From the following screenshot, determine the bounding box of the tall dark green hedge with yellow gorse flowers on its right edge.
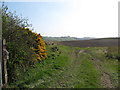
[2,3,47,83]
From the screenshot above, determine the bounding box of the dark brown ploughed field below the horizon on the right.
[61,38,120,47]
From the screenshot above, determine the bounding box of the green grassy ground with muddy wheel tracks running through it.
[7,45,118,88]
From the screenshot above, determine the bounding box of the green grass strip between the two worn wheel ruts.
[75,53,101,88]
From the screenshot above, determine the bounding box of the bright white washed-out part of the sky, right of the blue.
[51,0,118,37]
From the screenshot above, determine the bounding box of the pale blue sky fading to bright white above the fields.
[4,0,119,38]
